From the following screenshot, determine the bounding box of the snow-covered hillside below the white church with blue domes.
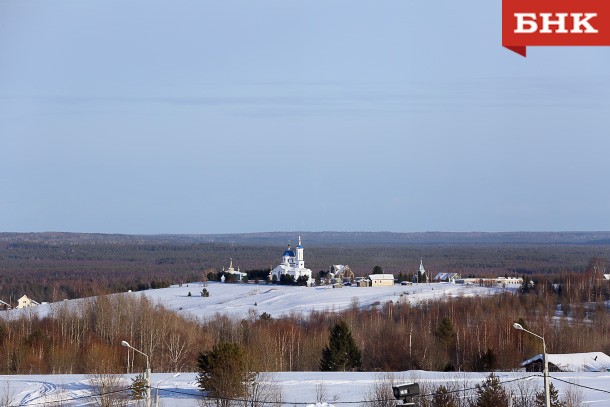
[10,282,504,318]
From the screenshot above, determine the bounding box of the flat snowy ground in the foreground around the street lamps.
[0,371,610,407]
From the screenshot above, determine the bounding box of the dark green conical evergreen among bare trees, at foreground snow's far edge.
[320,321,362,372]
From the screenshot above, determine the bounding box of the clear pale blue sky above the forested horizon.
[0,0,610,234]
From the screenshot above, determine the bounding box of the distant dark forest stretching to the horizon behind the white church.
[0,232,610,304]
